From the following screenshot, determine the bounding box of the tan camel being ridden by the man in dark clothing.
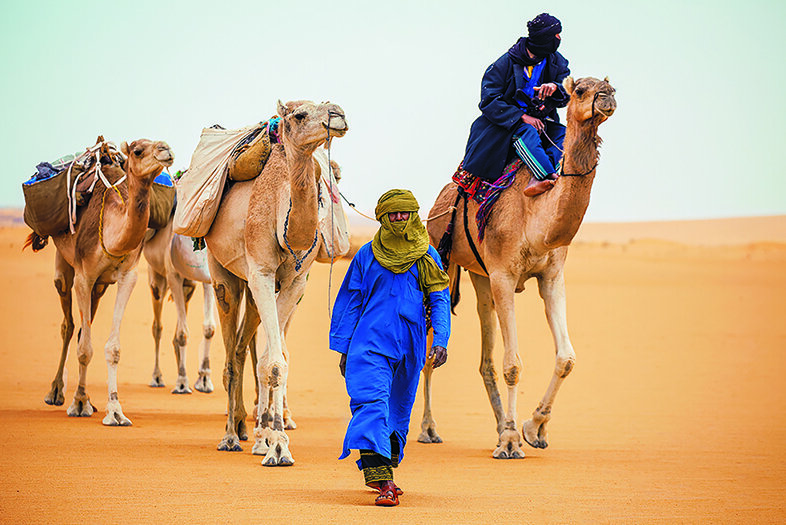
[418,77,617,459]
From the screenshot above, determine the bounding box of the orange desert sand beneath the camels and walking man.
[0,217,786,524]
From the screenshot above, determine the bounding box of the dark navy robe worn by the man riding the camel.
[464,53,570,181]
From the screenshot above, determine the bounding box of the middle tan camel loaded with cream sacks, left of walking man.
[205,101,348,466]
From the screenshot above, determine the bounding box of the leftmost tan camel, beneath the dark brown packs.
[34,139,174,426]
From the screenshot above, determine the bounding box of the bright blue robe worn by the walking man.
[330,242,450,460]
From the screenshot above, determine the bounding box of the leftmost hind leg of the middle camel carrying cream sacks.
[208,254,243,452]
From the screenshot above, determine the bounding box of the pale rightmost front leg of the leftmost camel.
[103,270,137,427]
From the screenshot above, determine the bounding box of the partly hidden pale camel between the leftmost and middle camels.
[143,216,216,394]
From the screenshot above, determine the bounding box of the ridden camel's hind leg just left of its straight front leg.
[469,273,505,434]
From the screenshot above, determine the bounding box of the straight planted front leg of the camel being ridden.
[489,272,524,459]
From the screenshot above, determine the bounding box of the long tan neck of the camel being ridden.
[528,119,599,250]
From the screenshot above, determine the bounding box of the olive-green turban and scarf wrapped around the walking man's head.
[371,190,450,297]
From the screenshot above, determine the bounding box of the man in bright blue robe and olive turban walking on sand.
[330,190,450,506]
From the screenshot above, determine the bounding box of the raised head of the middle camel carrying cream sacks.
[278,100,349,153]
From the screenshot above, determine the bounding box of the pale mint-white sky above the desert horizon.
[0,0,786,222]
